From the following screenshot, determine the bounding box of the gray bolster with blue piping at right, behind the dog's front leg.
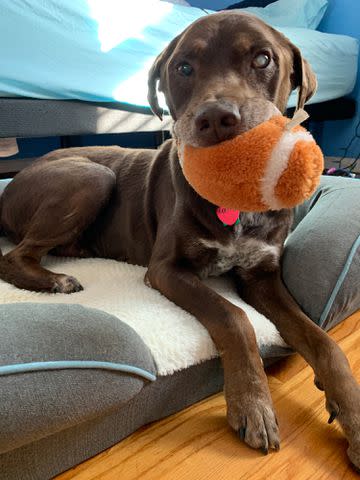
[282,176,360,329]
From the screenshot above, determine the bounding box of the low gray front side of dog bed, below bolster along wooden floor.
[0,359,223,480]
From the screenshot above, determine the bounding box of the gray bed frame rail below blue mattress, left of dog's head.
[0,98,171,138]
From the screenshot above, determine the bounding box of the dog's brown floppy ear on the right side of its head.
[291,45,317,108]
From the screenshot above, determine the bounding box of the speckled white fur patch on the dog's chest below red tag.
[200,237,280,278]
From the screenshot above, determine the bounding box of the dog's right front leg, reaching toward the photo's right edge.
[238,271,360,468]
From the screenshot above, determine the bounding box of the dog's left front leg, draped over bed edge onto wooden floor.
[145,261,279,453]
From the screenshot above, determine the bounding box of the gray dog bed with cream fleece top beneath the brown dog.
[0,178,360,480]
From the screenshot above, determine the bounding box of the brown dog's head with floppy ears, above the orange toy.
[148,12,316,146]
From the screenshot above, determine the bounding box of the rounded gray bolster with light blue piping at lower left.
[0,303,156,453]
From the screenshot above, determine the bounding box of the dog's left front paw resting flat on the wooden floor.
[227,392,280,454]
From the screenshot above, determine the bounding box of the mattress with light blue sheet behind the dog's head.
[0,0,358,106]
